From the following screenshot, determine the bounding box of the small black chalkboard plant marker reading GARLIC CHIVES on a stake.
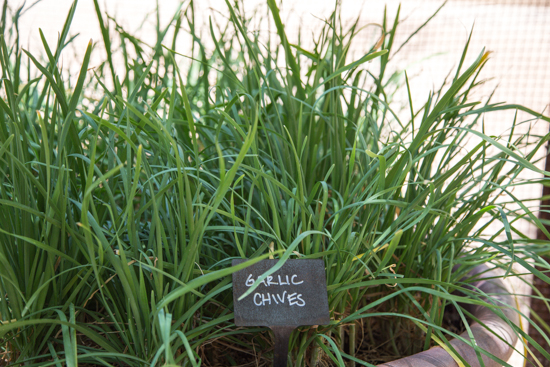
[233,259,330,367]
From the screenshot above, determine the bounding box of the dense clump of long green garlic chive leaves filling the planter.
[0,0,550,367]
